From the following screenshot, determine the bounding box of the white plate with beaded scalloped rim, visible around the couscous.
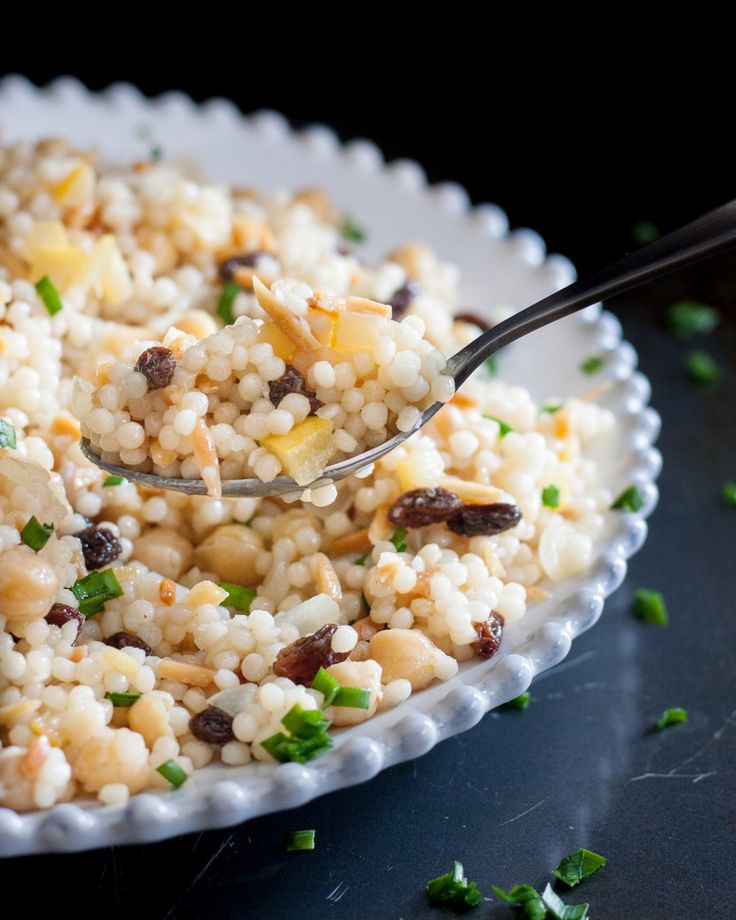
[0,77,661,856]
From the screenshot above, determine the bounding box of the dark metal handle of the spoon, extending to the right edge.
[446,201,736,388]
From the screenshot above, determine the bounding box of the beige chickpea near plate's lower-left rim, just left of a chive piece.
[73,728,151,793]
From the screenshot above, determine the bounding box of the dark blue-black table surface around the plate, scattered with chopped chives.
[0,91,736,920]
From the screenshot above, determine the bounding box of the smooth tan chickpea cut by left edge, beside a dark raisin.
[0,547,59,626]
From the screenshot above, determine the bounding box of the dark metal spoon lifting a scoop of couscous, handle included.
[81,201,736,496]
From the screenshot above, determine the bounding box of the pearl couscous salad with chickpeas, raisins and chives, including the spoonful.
[0,139,614,811]
